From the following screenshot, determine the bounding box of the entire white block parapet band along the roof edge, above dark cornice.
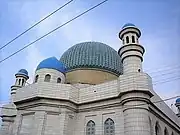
[12,73,179,128]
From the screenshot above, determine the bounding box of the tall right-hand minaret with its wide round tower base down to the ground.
[118,23,153,135]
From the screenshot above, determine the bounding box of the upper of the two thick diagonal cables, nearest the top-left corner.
[0,0,73,50]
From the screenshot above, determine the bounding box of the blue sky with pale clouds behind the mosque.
[0,0,180,114]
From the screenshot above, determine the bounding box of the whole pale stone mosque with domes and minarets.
[1,23,180,135]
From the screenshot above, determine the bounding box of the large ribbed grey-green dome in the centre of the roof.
[60,42,122,75]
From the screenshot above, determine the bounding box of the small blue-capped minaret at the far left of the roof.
[11,69,29,101]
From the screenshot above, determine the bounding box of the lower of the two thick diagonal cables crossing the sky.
[0,0,108,63]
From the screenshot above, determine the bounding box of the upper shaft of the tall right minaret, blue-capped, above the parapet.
[118,23,145,73]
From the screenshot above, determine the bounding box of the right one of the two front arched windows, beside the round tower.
[104,118,115,135]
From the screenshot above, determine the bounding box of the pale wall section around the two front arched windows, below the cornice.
[74,108,124,135]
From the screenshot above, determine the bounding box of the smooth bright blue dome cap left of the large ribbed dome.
[36,57,66,73]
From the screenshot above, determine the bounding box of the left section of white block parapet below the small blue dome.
[14,82,78,102]
